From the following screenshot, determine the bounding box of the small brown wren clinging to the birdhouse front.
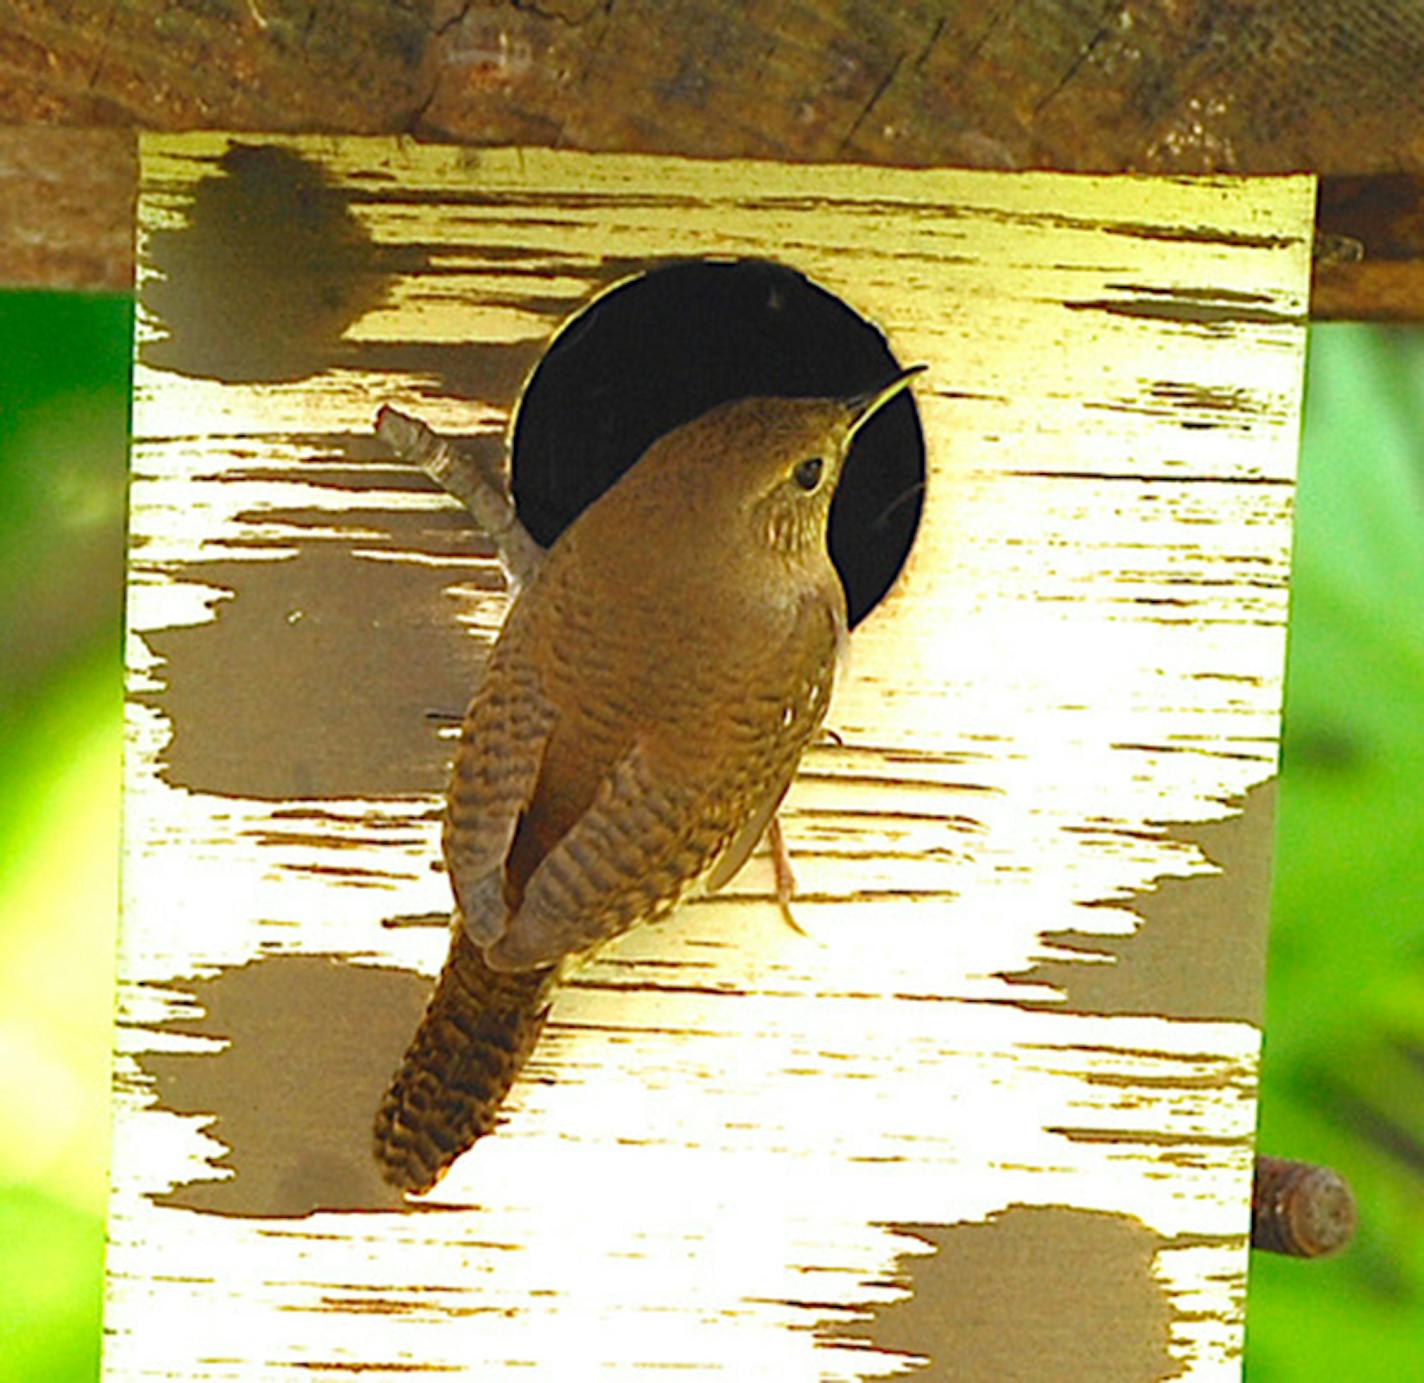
[375,366,923,1192]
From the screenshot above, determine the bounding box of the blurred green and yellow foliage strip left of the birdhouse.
[0,292,132,1383]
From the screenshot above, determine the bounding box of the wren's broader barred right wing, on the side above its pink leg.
[486,742,763,970]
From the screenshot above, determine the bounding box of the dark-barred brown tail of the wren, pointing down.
[375,916,555,1194]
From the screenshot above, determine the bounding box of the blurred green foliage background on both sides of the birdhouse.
[0,293,1424,1383]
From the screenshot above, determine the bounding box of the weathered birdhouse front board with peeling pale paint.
[105,134,1313,1380]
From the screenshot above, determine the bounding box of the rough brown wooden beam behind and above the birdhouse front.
[0,0,1424,311]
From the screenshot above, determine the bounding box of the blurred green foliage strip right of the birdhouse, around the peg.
[1246,325,1424,1383]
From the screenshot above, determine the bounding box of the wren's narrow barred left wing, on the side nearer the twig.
[444,665,557,944]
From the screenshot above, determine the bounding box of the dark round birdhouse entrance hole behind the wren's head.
[513,259,924,624]
